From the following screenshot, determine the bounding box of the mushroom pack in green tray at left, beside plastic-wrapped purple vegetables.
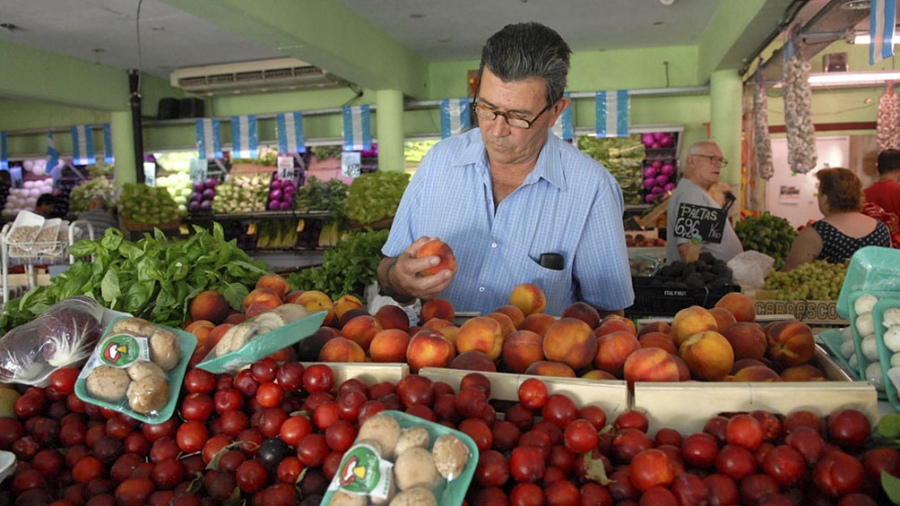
[75,317,197,423]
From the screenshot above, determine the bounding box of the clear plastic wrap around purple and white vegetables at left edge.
[0,296,104,384]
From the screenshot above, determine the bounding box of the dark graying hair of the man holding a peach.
[478,22,572,104]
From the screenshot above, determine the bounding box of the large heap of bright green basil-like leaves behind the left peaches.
[0,223,269,331]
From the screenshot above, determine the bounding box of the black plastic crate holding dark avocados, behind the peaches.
[625,277,741,318]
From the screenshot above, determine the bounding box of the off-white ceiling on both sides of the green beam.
[0,0,760,78]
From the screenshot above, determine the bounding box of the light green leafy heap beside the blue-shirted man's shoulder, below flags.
[346,170,409,225]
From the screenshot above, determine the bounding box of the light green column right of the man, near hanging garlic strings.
[709,69,743,185]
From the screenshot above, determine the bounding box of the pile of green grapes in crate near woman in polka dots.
[765,260,847,300]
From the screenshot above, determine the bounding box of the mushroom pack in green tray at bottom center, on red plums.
[322,411,478,506]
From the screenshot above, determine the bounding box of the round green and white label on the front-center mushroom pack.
[329,444,393,499]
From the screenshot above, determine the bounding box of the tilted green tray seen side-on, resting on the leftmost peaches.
[197,311,328,374]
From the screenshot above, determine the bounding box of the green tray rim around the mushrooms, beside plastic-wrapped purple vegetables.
[75,316,197,424]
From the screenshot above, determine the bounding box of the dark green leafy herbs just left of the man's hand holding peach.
[287,228,390,300]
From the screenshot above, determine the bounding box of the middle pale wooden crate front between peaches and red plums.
[419,367,628,420]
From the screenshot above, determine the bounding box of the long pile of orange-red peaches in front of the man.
[185,274,824,381]
